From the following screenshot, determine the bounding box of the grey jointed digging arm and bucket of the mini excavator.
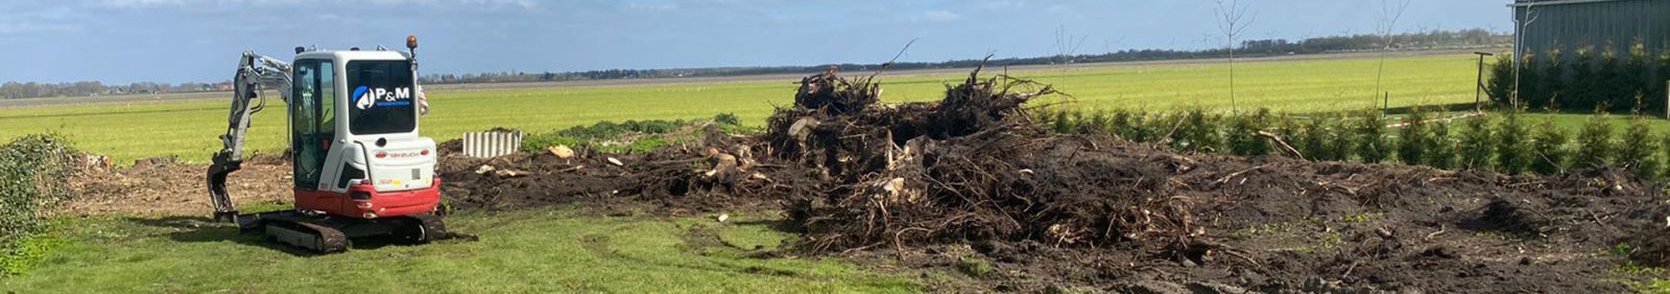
[209,52,291,226]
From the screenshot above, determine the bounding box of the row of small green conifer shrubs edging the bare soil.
[1037,107,1670,179]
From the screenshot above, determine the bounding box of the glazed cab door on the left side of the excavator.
[291,60,336,190]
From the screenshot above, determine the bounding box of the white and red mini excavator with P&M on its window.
[209,35,448,252]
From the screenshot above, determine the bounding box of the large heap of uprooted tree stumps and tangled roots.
[765,67,1192,252]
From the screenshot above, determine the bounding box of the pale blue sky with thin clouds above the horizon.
[0,0,1513,84]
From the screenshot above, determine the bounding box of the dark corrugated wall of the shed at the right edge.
[1513,0,1670,57]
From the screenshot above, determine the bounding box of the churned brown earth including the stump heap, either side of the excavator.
[61,68,1670,292]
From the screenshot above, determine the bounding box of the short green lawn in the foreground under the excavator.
[0,209,928,292]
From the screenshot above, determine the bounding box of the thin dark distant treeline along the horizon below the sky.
[0,28,1513,99]
